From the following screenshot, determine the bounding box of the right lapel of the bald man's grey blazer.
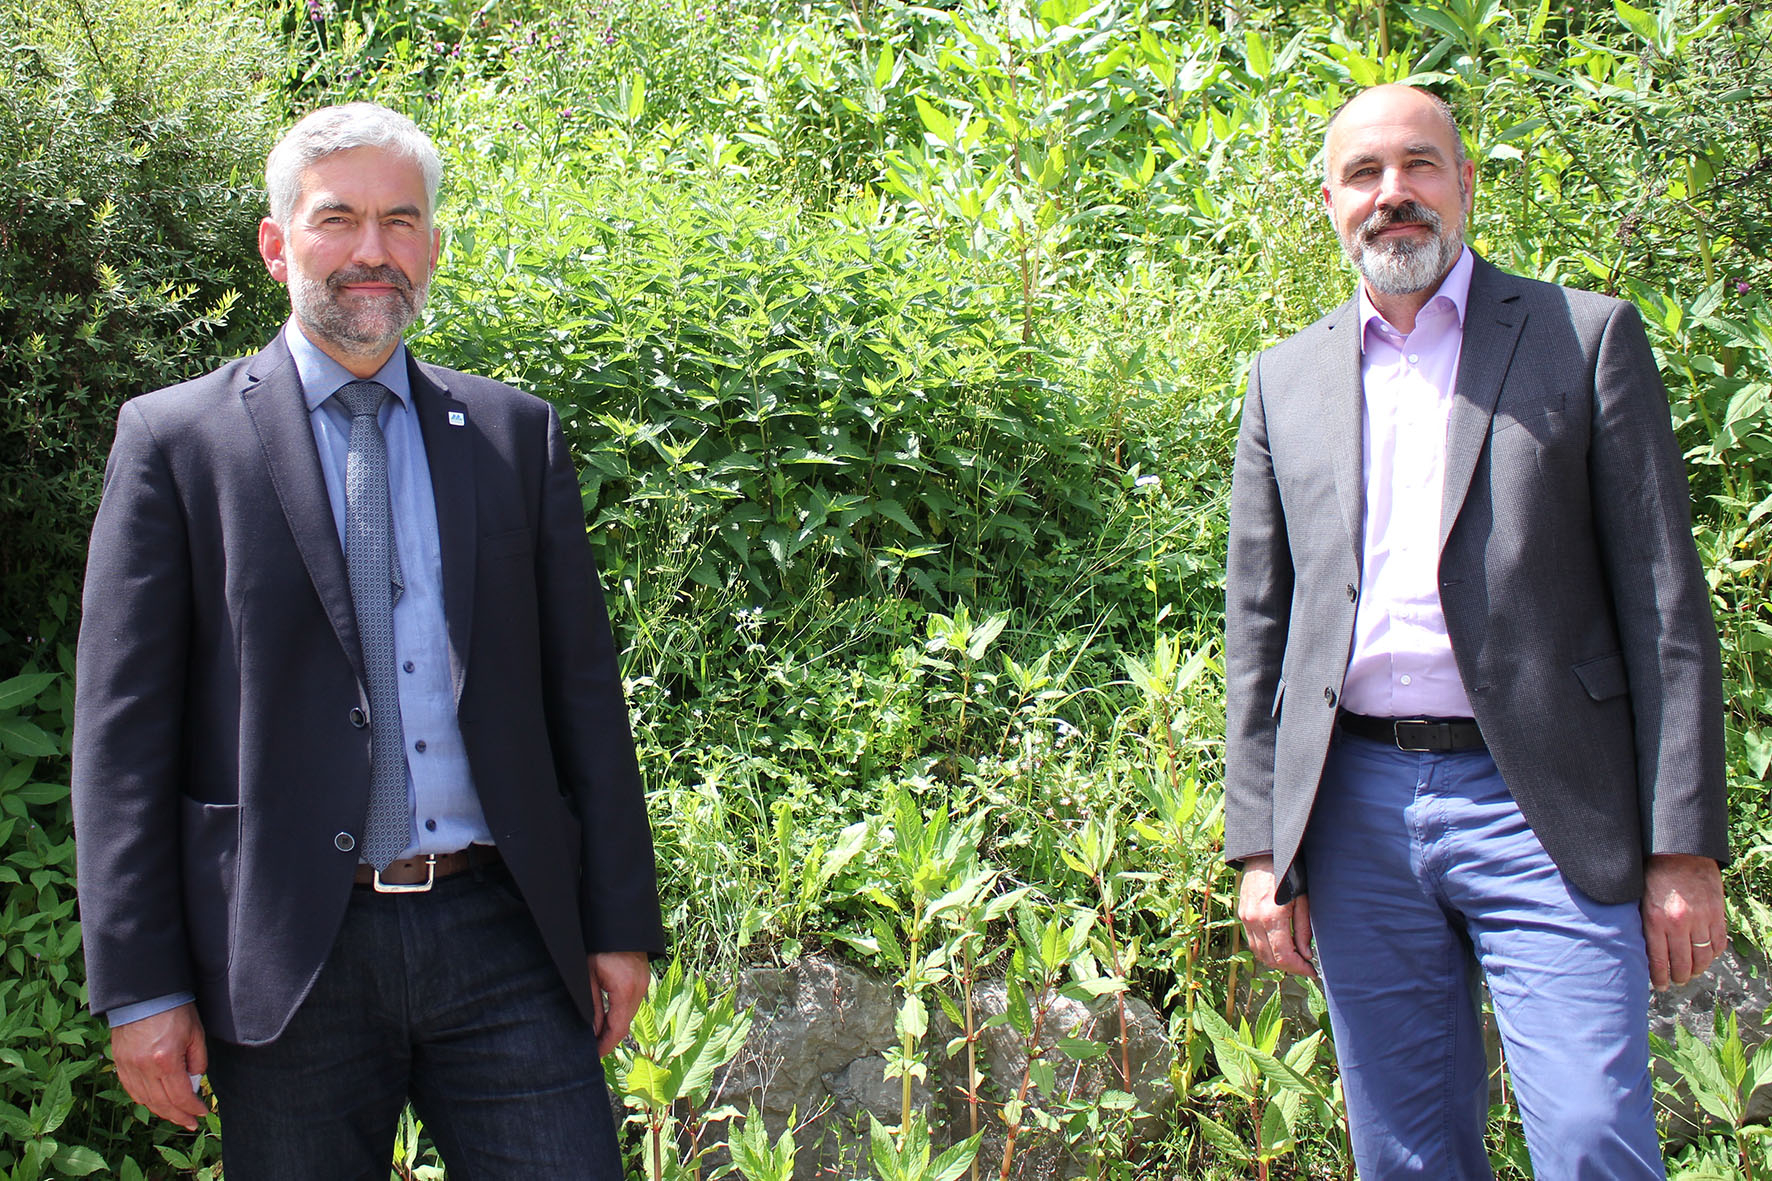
[1439,259,1526,550]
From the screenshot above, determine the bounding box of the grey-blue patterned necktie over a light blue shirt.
[333,381,411,871]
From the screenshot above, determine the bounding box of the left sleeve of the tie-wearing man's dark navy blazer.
[73,403,193,1013]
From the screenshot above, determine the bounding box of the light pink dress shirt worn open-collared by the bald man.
[1341,248,1473,718]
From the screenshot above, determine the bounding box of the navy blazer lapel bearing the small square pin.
[406,358,480,706]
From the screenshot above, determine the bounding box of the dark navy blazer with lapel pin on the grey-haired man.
[73,337,663,1044]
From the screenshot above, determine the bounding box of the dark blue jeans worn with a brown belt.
[209,865,622,1181]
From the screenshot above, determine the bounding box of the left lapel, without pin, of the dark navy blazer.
[241,335,367,684]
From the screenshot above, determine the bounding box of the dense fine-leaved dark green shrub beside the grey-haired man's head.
[0,0,287,669]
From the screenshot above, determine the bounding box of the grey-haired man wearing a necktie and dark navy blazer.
[73,103,663,1181]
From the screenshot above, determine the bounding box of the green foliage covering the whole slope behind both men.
[0,0,1772,1181]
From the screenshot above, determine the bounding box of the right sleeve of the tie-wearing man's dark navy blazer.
[537,406,665,956]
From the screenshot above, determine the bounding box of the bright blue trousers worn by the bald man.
[1304,732,1666,1181]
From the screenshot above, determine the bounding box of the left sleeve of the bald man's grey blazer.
[1224,356,1294,862]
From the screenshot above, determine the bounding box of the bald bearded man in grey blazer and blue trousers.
[1224,87,1728,1181]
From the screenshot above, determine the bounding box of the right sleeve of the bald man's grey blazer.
[1588,303,1728,864]
